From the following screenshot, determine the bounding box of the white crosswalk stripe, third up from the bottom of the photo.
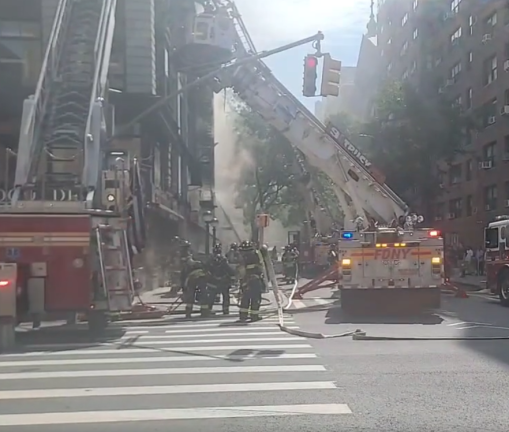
[0,365,326,381]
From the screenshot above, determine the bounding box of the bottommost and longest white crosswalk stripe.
[0,404,352,426]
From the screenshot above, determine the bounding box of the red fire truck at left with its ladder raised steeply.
[0,0,145,331]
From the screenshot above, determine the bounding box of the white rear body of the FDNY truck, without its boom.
[338,228,444,310]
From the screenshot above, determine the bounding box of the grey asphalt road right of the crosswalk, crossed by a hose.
[288,284,509,432]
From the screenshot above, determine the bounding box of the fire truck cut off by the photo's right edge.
[484,216,509,307]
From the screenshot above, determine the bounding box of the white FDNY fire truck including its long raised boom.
[191,0,444,308]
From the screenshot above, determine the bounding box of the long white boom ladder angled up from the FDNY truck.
[212,2,411,230]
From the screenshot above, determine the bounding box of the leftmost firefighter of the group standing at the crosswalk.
[181,242,211,318]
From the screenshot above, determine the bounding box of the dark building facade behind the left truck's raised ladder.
[0,0,214,286]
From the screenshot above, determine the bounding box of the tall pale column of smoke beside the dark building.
[214,94,249,243]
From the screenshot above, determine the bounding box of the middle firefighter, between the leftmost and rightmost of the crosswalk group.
[208,244,235,315]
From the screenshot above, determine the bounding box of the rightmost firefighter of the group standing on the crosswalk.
[238,241,265,322]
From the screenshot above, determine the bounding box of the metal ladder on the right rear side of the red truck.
[95,224,135,312]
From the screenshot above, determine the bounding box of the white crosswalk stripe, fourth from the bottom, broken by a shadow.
[0,339,313,361]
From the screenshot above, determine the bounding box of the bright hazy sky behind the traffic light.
[235,0,370,111]
